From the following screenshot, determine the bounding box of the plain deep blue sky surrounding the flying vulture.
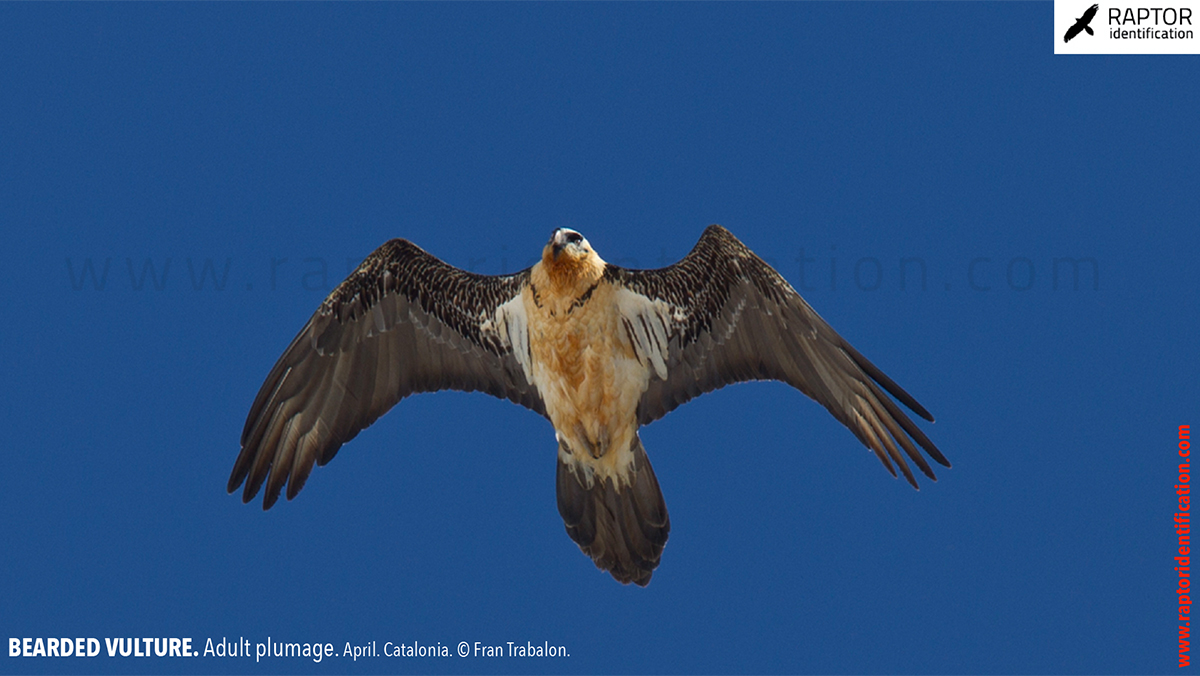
[0,2,1200,674]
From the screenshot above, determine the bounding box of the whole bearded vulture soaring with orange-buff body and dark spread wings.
[228,226,950,586]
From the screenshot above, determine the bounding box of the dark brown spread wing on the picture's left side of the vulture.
[228,239,545,509]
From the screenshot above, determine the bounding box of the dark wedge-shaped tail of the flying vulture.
[557,436,671,587]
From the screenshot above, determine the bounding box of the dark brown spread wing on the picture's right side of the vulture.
[606,226,950,487]
